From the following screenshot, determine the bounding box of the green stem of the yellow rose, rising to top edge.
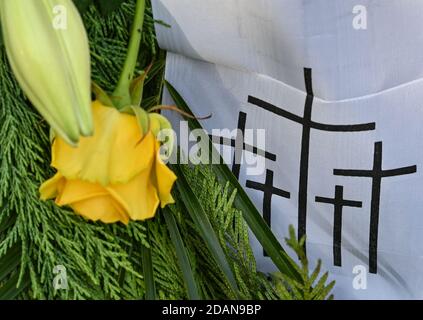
[112,0,145,109]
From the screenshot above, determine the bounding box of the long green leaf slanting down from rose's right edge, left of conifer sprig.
[170,165,238,295]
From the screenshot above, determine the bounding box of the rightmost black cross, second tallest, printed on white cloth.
[333,142,417,273]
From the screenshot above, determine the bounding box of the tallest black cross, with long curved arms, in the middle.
[248,68,376,249]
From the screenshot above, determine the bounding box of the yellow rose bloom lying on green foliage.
[40,101,176,224]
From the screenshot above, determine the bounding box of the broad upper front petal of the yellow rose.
[52,101,154,186]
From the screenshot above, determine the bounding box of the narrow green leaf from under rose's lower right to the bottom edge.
[163,207,201,300]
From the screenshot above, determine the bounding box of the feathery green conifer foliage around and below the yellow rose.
[0,0,331,299]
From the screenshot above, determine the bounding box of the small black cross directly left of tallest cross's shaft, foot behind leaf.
[246,170,291,256]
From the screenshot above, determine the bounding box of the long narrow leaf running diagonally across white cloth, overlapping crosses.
[165,81,301,281]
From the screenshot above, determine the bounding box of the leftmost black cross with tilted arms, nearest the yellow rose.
[210,112,276,179]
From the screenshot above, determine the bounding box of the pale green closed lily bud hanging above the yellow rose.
[0,0,93,144]
